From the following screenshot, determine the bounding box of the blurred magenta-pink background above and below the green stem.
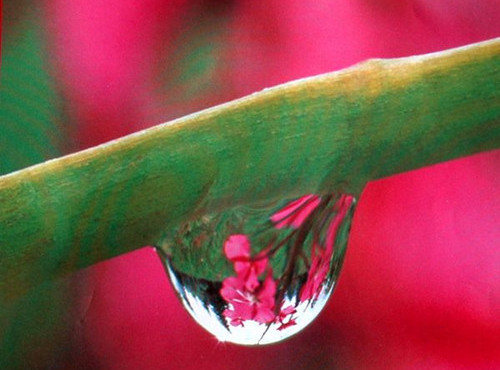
[46,0,500,369]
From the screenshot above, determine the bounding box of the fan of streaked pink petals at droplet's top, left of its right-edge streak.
[271,194,321,229]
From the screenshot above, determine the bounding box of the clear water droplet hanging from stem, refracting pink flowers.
[158,194,354,345]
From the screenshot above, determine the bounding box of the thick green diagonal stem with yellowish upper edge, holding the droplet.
[0,39,500,304]
